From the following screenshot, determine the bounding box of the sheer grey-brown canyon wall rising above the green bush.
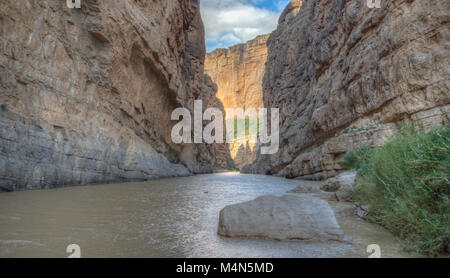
[245,0,450,179]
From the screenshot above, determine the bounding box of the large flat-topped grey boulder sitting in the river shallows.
[218,195,344,241]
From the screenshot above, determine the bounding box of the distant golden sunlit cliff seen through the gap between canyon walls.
[205,35,269,168]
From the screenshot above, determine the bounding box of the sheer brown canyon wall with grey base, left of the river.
[0,0,225,190]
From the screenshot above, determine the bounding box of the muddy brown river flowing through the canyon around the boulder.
[0,173,411,258]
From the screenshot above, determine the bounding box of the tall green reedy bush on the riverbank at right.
[344,123,450,256]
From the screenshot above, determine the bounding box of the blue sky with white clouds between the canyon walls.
[200,0,290,52]
